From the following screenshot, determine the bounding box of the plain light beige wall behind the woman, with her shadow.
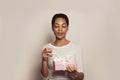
[0,0,120,80]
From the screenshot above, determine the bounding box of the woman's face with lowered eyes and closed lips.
[52,18,68,39]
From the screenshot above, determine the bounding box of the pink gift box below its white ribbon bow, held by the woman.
[54,62,74,71]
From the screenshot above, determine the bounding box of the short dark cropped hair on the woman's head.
[51,13,69,26]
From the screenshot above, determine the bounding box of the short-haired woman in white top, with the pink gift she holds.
[41,13,84,80]
